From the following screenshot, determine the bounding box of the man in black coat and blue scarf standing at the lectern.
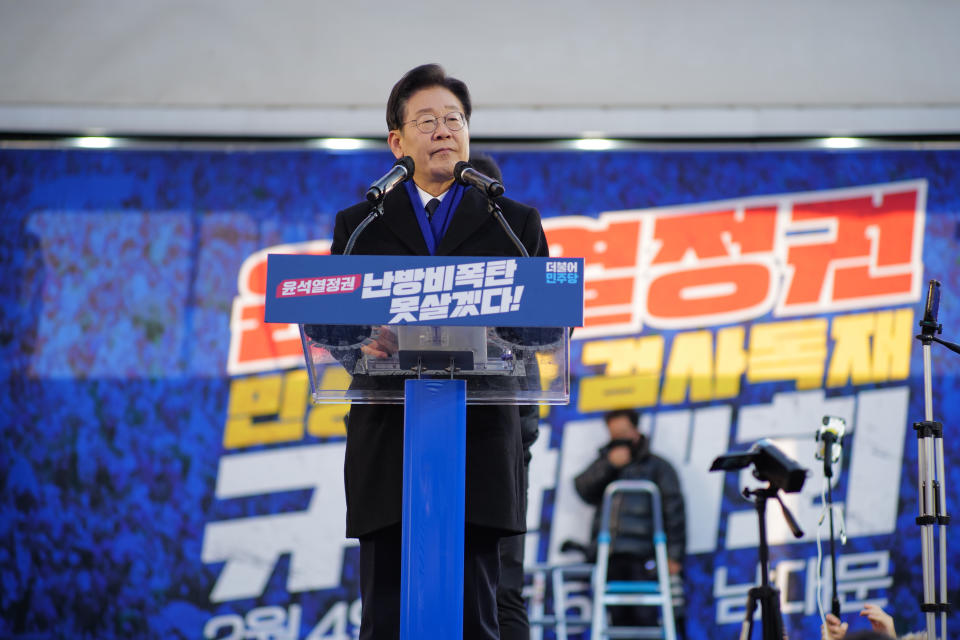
[330,65,548,640]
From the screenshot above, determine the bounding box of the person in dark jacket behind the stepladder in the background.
[574,409,687,631]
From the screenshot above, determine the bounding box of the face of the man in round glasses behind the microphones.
[387,86,470,195]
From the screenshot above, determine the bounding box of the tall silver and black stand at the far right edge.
[913,280,960,639]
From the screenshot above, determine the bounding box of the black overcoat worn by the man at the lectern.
[330,188,548,537]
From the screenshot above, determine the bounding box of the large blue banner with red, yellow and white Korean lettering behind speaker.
[0,149,960,640]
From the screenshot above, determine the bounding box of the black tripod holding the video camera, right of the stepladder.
[740,486,803,640]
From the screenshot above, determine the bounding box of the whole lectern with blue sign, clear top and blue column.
[265,255,583,640]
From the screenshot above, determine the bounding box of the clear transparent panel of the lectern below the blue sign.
[300,325,570,404]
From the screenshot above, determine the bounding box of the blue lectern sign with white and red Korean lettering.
[265,254,583,327]
